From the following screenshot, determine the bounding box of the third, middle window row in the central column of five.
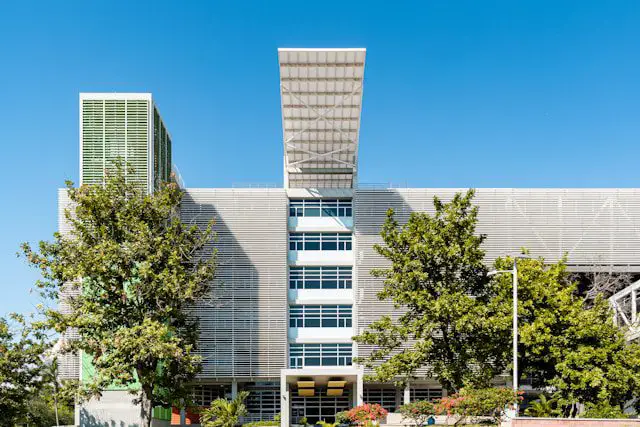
[289,266,353,289]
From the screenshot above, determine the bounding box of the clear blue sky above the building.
[0,0,640,315]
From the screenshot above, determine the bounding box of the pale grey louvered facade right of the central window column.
[354,188,640,375]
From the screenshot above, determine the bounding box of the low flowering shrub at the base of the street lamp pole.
[436,387,522,426]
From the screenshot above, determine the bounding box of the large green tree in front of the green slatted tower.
[23,162,215,426]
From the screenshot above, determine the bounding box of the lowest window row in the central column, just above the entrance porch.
[289,344,352,368]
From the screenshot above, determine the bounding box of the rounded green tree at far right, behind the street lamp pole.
[491,258,640,416]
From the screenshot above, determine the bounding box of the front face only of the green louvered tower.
[81,99,149,188]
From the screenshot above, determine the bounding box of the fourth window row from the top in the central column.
[289,305,351,328]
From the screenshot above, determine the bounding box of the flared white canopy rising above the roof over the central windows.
[278,48,366,188]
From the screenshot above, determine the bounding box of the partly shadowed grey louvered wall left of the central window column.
[181,189,287,379]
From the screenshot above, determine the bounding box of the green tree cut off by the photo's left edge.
[0,314,50,426]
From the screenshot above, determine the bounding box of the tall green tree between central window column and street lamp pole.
[354,190,508,393]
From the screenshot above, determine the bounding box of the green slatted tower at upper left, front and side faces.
[80,97,171,193]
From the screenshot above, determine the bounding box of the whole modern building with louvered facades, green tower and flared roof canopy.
[59,49,640,426]
